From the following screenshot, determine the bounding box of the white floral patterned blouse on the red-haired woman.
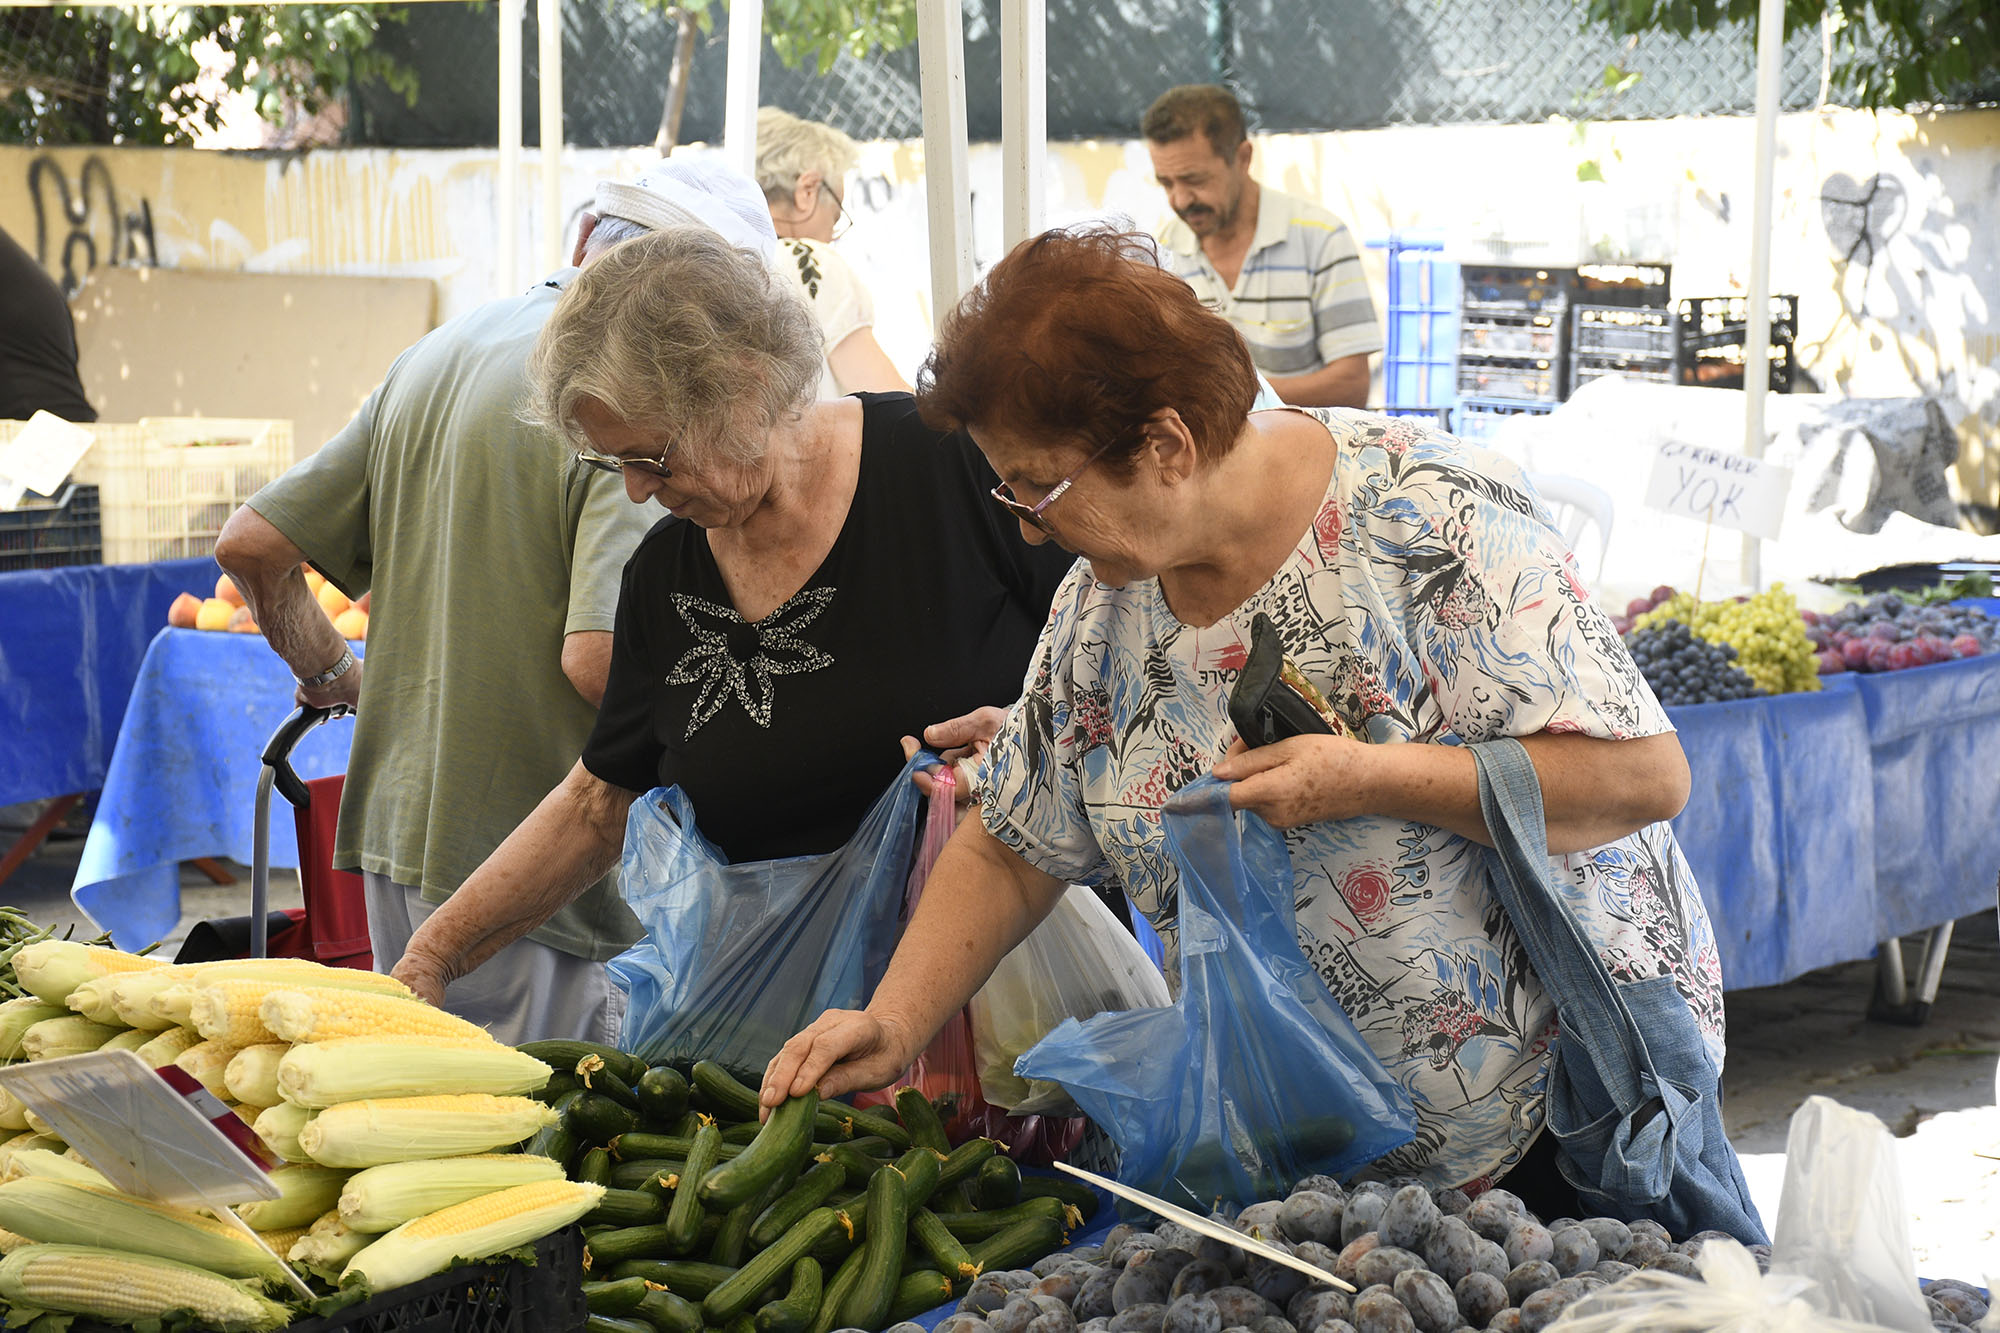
[982,410,1722,1185]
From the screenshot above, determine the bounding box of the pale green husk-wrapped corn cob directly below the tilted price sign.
[0,1177,282,1281]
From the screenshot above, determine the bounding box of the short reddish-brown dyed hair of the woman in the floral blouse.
[916,226,1256,468]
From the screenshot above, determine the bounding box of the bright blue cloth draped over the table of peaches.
[70,628,362,949]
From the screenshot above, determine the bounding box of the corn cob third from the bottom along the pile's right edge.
[298,1093,556,1167]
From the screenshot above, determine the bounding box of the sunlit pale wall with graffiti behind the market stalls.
[0,110,2000,504]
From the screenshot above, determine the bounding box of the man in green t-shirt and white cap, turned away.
[216,158,776,1045]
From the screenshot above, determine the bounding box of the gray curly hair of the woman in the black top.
[522,226,822,462]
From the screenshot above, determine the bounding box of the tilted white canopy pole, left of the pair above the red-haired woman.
[916,0,972,326]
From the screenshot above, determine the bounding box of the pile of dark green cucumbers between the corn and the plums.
[520,1041,1098,1333]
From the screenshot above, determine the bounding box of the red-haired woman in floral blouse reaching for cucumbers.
[764,230,1722,1215]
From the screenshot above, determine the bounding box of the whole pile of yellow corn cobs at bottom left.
[0,941,604,1331]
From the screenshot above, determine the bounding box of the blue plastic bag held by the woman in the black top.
[608,755,938,1087]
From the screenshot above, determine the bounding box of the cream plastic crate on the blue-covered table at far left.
[0,416,292,564]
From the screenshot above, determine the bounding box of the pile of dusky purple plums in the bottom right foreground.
[916,1175,1986,1333]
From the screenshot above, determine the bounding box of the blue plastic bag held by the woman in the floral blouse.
[1014,779,1416,1211]
